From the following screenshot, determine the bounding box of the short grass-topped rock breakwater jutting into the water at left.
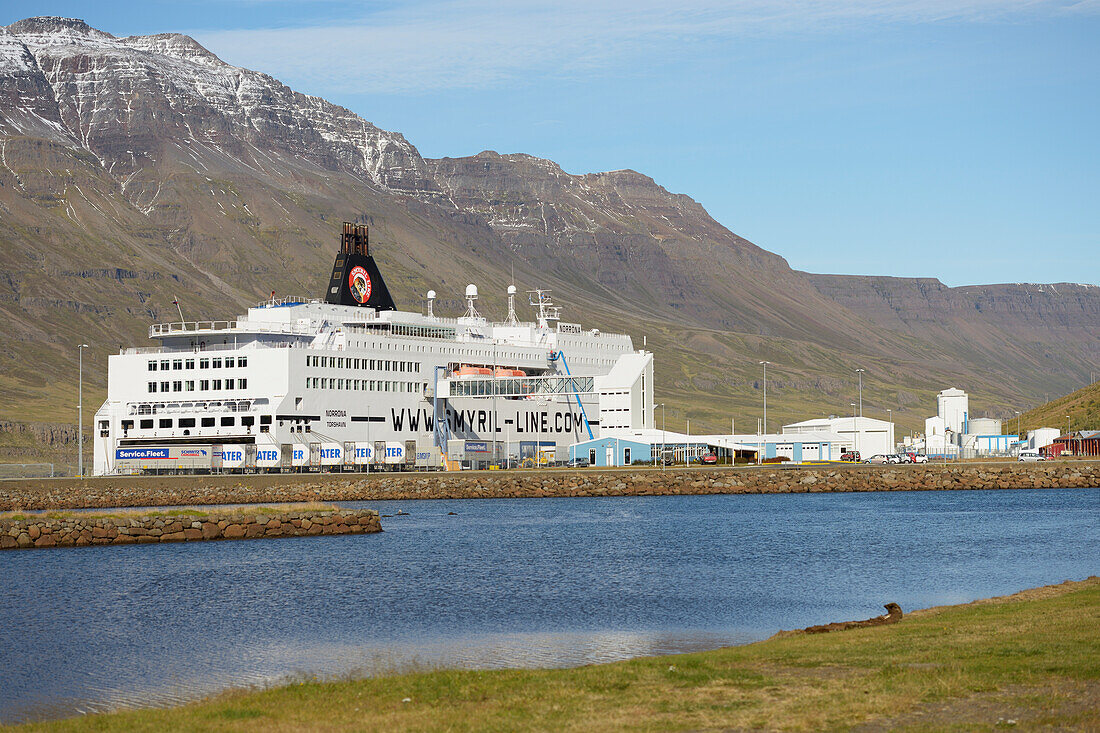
[0,506,382,549]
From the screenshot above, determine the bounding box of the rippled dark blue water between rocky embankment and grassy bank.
[0,489,1100,722]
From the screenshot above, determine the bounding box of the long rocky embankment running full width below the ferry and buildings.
[0,460,1100,511]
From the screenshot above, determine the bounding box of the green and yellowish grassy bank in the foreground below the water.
[10,578,1100,731]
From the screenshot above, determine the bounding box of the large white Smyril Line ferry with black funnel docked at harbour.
[94,223,653,475]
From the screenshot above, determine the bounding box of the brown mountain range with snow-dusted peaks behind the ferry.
[0,18,1100,473]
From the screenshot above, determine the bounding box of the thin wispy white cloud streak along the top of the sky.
[193,0,1100,94]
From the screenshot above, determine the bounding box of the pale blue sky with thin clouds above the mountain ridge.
[0,0,1100,285]
